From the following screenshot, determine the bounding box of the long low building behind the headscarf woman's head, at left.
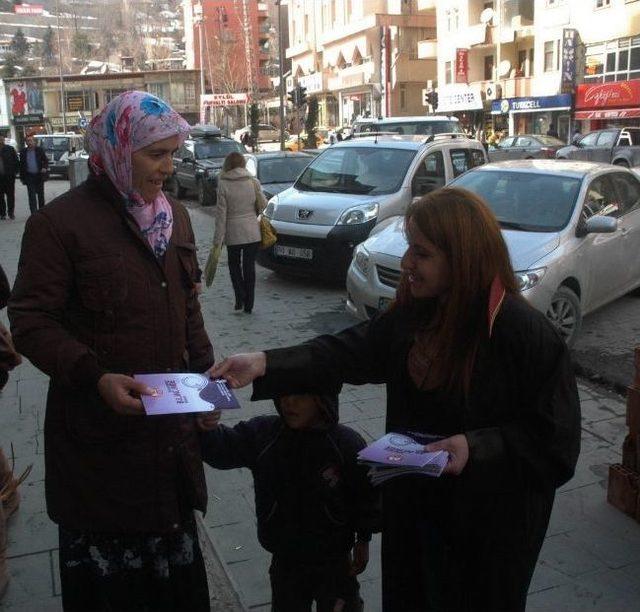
[0,70,200,138]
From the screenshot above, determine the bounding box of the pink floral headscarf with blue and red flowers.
[86,91,189,257]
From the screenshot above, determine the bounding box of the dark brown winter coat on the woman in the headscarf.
[9,172,213,532]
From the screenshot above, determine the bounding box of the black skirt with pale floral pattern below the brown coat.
[59,523,210,612]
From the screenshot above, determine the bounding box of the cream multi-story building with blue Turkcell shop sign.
[418,0,640,139]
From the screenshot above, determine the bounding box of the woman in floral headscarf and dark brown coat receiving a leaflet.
[9,91,213,611]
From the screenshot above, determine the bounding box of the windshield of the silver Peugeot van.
[295,146,416,195]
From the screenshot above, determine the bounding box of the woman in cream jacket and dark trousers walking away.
[213,152,267,313]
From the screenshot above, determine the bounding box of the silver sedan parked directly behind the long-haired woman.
[347,160,640,346]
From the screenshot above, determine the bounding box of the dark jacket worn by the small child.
[202,415,380,561]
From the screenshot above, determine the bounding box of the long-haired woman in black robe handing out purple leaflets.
[212,188,580,612]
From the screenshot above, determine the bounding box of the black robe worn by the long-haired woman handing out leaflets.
[254,296,580,612]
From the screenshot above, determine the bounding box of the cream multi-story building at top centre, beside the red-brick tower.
[286,0,436,126]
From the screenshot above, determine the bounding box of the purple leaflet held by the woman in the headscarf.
[134,372,240,415]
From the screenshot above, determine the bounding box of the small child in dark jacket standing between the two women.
[202,395,380,612]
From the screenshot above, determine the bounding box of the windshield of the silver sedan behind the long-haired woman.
[451,170,582,232]
